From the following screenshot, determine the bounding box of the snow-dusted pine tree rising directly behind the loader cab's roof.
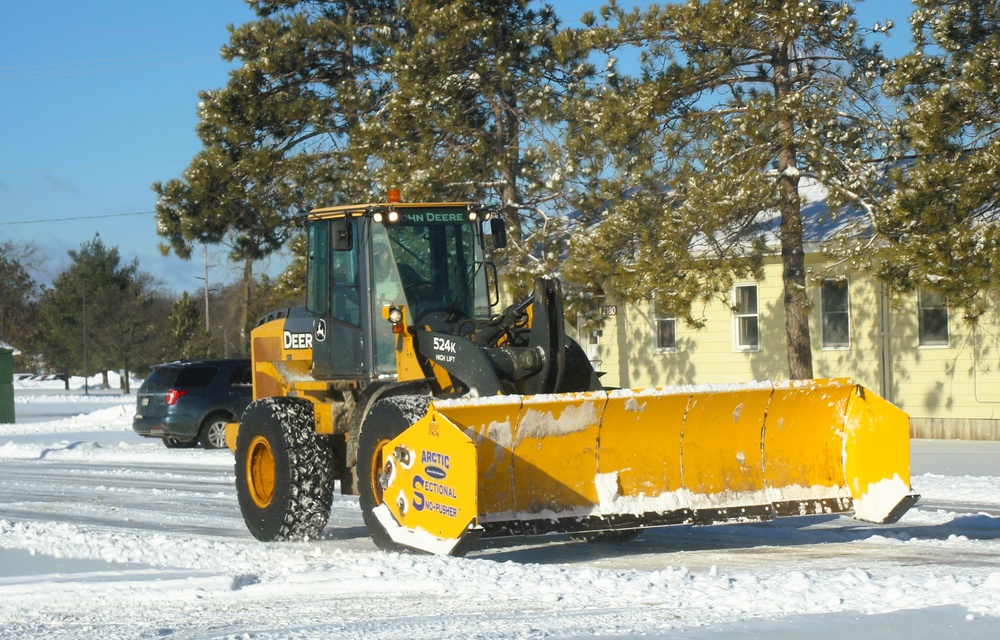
[370,0,565,222]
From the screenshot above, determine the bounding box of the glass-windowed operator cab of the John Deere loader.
[307,204,496,379]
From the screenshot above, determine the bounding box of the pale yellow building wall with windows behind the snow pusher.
[575,195,1000,440]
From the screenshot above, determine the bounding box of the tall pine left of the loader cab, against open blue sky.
[153,0,395,332]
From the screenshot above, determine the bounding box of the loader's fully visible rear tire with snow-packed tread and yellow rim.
[236,398,334,542]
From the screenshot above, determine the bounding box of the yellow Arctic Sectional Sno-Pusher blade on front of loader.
[377,379,918,554]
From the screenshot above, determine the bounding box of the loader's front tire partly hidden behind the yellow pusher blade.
[357,396,431,551]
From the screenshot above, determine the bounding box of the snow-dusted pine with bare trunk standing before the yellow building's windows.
[563,0,896,378]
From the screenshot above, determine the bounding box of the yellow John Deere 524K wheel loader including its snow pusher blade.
[227,197,917,555]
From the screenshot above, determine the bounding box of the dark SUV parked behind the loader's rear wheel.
[132,360,253,449]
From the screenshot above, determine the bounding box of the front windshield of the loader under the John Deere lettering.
[384,208,489,321]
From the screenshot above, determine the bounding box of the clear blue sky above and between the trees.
[0,0,910,293]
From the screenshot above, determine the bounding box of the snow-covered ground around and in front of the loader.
[0,383,1000,640]
